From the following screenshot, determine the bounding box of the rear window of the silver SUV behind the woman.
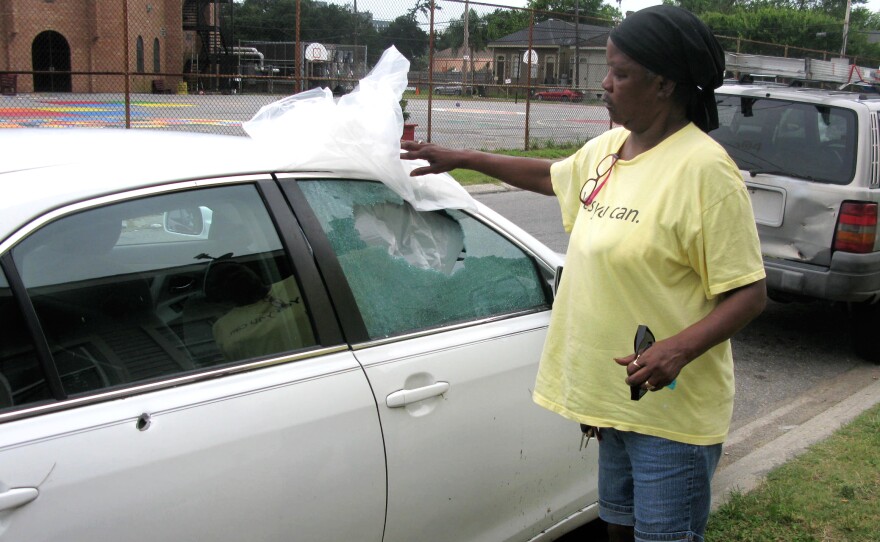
[710,94,858,184]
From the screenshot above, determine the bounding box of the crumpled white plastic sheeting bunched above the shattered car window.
[242,46,476,211]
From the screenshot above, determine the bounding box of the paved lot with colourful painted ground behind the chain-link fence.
[0,91,608,150]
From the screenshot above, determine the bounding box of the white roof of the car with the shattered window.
[0,129,334,240]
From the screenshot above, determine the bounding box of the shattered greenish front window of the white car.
[299,180,549,338]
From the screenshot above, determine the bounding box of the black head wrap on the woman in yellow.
[610,5,724,132]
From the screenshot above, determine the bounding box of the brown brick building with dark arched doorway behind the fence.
[0,0,229,92]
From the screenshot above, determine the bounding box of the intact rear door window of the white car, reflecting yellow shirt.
[13,185,315,395]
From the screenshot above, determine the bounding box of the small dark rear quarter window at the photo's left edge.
[0,271,44,412]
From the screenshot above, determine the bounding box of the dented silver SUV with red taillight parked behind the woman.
[711,85,880,362]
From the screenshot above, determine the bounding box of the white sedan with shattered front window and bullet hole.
[0,130,598,542]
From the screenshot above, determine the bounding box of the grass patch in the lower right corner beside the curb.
[706,405,880,542]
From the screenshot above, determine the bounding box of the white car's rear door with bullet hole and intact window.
[0,180,385,542]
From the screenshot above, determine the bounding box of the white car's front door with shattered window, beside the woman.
[285,180,596,542]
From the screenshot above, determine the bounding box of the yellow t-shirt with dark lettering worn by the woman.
[534,124,764,445]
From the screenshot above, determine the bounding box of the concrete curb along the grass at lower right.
[712,365,880,510]
